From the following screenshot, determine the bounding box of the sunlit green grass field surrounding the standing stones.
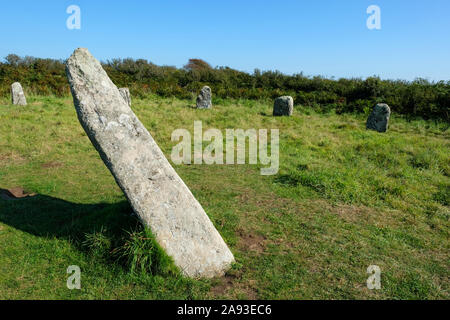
[0,97,450,299]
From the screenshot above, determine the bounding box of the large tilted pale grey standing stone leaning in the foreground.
[66,48,234,278]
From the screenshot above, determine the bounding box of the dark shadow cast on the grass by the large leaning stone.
[0,190,140,242]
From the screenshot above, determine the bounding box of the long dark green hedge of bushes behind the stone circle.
[0,54,450,121]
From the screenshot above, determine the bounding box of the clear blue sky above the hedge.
[0,0,450,80]
